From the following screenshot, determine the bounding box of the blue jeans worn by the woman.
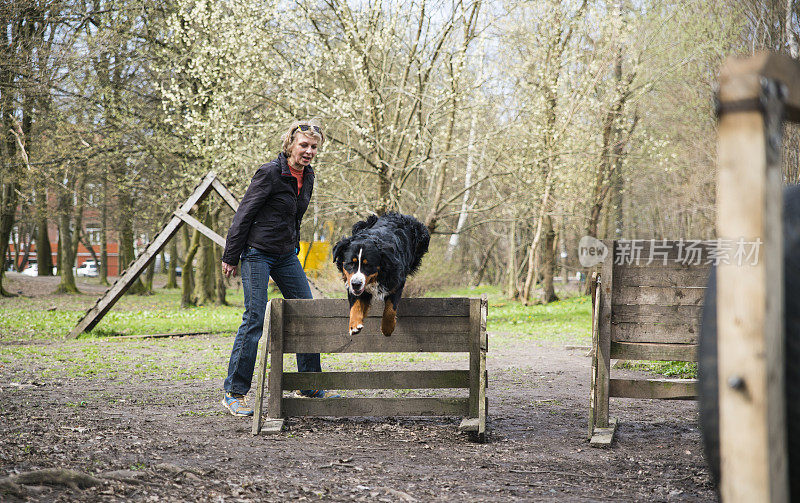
[224,246,322,395]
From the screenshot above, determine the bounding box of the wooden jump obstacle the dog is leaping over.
[252,296,488,441]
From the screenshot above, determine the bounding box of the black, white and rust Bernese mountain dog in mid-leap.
[333,212,431,336]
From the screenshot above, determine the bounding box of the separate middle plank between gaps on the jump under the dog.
[283,370,469,390]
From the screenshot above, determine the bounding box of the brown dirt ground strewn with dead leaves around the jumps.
[0,278,717,502]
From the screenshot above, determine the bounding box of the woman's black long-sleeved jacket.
[222,154,314,265]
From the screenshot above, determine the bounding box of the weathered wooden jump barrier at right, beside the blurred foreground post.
[589,240,716,446]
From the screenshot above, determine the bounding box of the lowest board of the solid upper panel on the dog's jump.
[284,330,469,353]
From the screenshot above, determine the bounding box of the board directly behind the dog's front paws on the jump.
[283,316,477,341]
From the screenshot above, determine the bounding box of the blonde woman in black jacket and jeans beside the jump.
[222,121,330,416]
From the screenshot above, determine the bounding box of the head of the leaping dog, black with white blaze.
[333,237,382,296]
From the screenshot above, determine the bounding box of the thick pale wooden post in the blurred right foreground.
[717,54,800,503]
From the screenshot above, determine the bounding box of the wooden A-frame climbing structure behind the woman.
[69,171,323,339]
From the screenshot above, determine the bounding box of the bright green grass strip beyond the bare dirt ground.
[0,287,591,342]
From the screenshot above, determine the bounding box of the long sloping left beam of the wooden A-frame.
[69,172,216,338]
